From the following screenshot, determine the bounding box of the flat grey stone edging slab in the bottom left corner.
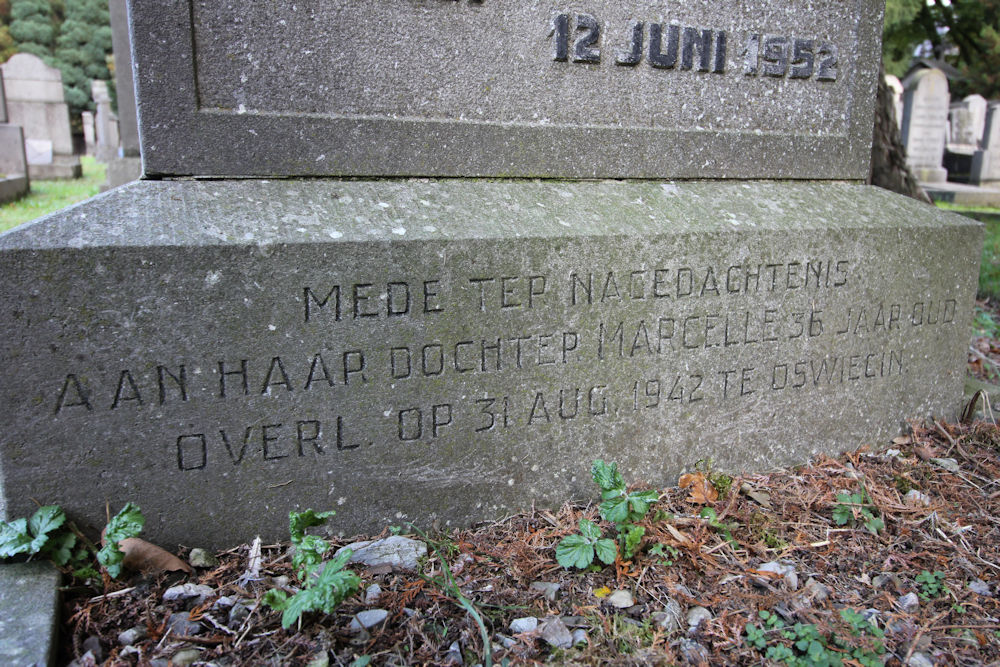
[0,563,62,667]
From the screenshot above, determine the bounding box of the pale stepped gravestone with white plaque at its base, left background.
[0,53,82,179]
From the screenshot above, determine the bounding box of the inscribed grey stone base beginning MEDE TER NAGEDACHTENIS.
[0,179,982,547]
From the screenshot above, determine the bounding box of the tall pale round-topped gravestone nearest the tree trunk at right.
[902,69,949,183]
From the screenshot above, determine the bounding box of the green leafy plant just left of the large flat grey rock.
[263,510,361,629]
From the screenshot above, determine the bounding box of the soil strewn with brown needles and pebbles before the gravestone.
[61,301,1000,667]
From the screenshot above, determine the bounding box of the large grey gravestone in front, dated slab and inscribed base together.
[0,0,982,546]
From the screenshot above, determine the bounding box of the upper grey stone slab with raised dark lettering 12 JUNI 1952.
[130,0,882,180]
